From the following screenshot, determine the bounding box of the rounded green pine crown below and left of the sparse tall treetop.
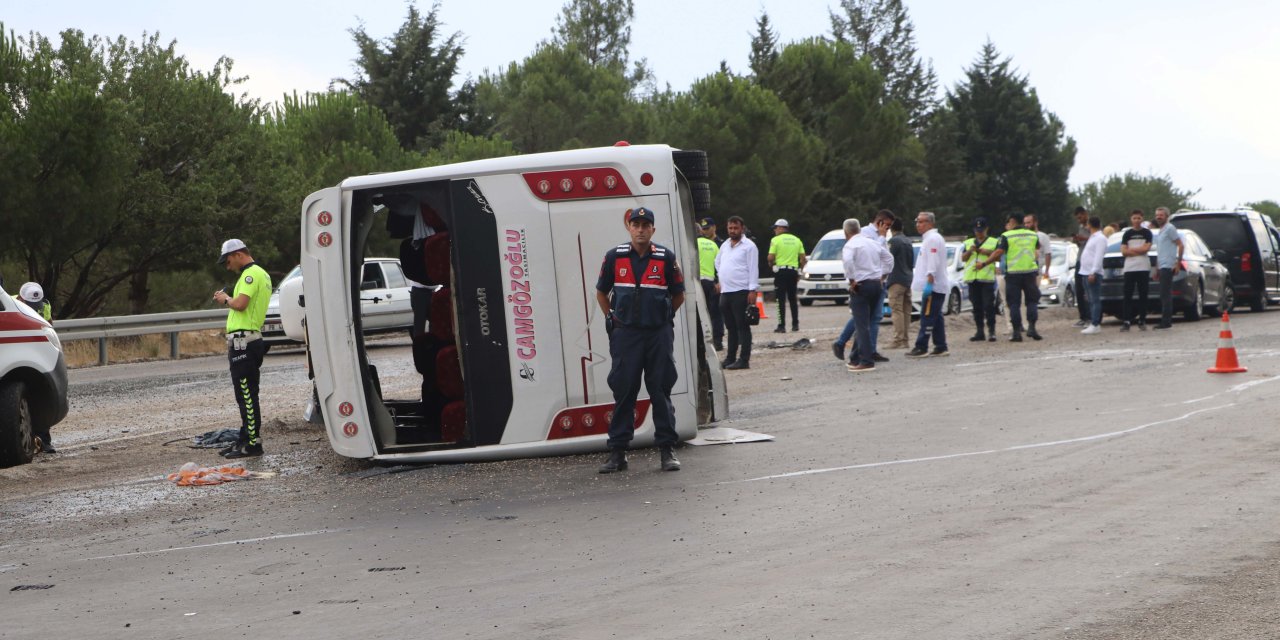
[767,38,923,228]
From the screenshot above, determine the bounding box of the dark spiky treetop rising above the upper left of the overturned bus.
[334,1,474,151]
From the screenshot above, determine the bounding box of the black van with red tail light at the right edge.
[1169,207,1280,311]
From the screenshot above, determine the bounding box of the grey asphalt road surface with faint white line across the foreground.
[0,306,1280,640]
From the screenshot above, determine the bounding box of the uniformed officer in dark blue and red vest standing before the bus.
[595,207,685,474]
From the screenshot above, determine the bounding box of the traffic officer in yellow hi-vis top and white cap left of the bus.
[214,238,271,458]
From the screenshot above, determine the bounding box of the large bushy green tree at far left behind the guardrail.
[0,29,256,317]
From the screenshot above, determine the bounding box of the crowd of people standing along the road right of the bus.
[698,207,1183,372]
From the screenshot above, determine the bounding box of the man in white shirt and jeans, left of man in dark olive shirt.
[841,219,893,372]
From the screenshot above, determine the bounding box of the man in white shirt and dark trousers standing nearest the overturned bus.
[716,215,760,369]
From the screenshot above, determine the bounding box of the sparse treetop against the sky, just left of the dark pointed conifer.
[831,0,938,131]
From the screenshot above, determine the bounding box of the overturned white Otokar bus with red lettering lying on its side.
[288,143,728,462]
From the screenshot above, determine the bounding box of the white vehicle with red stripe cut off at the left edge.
[0,282,67,467]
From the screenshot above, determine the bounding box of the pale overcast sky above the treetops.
[0,0,1280,206]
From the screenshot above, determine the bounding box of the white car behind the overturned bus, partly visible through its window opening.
[262,257,413,346]
